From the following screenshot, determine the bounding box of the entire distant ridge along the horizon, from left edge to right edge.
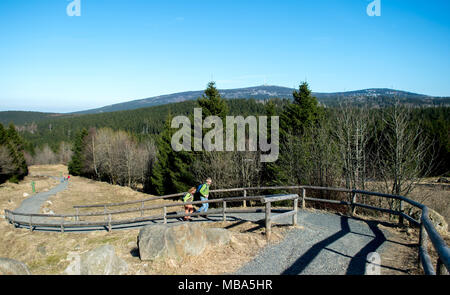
[0,85,450,125]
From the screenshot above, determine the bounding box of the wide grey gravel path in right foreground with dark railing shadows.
[235,210,391,275]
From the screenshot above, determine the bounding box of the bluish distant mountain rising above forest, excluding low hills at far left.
[73,86,450,114]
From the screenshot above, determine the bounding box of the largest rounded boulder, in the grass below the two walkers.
[137,223,208,260]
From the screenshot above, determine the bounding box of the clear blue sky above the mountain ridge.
[0,0,450,112]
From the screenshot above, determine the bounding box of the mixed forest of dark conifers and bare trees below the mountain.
[1,82,450,206]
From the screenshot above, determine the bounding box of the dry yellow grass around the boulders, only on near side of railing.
[0,215,287,275]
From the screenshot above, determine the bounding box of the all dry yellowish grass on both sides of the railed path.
[0,165,287,275]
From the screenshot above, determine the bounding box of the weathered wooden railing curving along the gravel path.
[5,186,450,275]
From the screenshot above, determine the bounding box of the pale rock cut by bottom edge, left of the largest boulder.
[64,245,128,275]
